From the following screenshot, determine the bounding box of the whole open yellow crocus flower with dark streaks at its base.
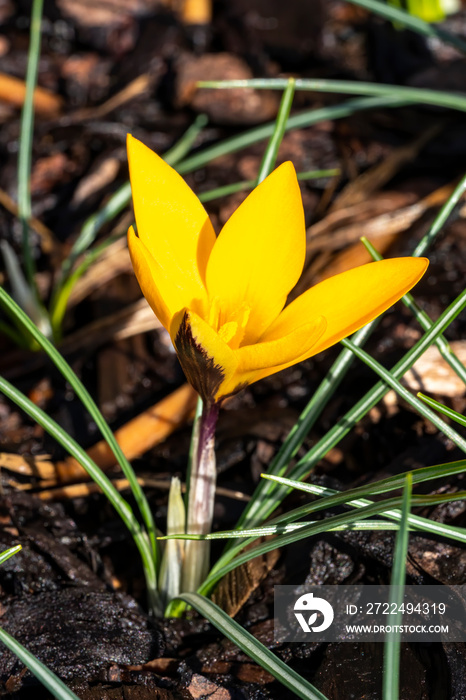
[128,135,428,404]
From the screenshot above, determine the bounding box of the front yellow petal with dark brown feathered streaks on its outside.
[170,309,238,403]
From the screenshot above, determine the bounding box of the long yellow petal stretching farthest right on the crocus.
[262,258,429,355]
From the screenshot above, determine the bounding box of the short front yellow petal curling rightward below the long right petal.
[219,316,327,396]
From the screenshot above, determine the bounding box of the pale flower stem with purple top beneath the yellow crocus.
[181,402,220,592]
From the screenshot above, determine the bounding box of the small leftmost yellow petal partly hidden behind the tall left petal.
[128,226,204,330]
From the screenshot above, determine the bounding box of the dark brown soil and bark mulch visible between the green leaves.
[0,0,466,700]
